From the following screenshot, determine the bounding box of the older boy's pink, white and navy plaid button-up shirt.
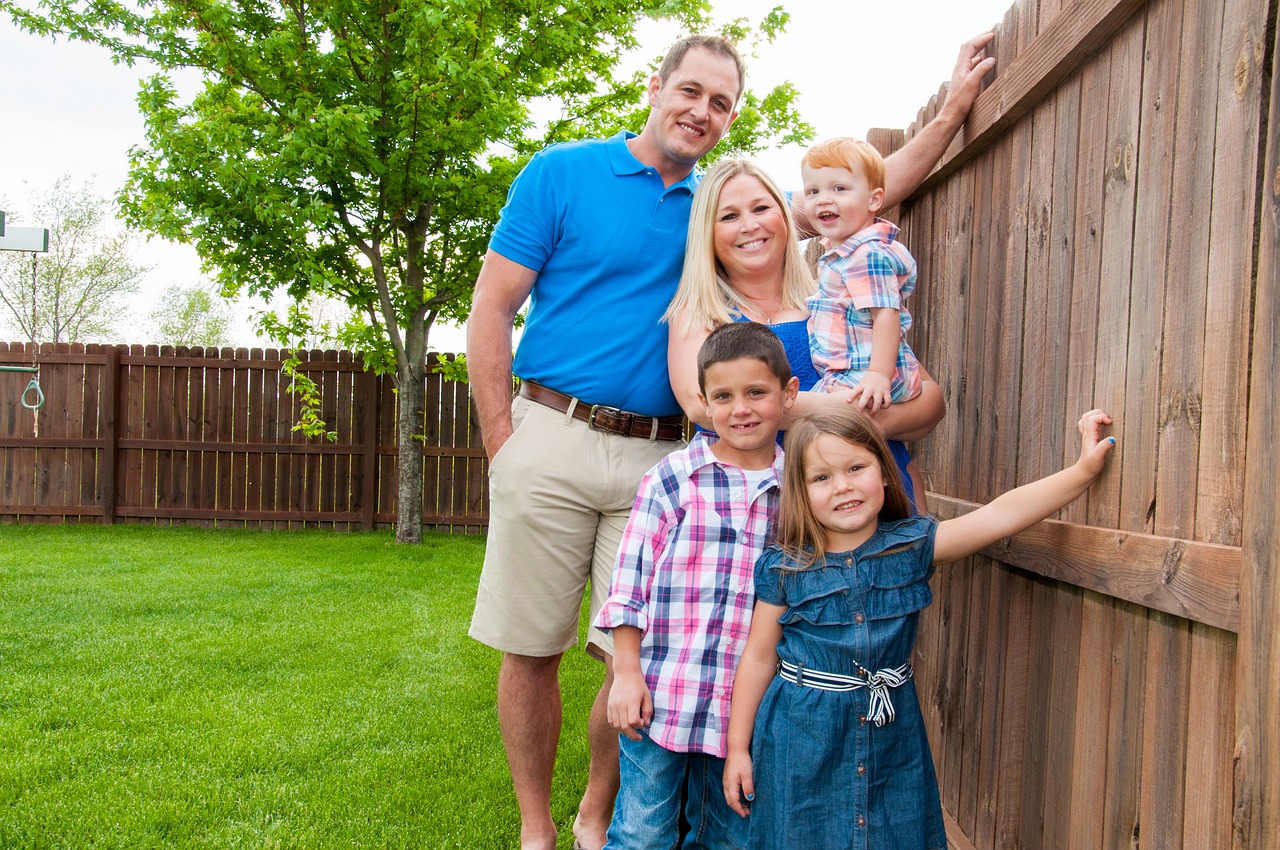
[595,434,782,758]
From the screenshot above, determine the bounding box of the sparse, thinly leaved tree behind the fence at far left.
[0,174,146,343]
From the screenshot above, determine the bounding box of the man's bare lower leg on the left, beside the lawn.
[498,653,563,850]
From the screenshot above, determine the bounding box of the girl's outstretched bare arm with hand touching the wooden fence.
[933,410,1115,563]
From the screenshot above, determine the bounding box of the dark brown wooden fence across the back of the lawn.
[0,343,488,531]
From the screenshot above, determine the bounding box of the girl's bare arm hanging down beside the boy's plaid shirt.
[723,602,787,818]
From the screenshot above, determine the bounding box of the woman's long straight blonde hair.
[662,160,814,330]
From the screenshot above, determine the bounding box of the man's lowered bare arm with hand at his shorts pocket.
[467,251,538,461]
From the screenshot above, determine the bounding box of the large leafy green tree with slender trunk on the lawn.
[0,0,809,541]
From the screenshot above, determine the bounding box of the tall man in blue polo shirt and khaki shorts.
[467,35,993,850]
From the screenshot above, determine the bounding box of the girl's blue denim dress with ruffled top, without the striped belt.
[750,516,946,850]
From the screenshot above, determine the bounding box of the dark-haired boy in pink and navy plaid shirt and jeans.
[595,323,797,850]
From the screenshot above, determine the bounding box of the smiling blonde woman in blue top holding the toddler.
[663,160,946,509]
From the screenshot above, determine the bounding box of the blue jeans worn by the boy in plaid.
[604,730,748,850]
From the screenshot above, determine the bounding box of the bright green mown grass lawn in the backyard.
[0,525,602,849]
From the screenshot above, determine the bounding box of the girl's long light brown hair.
[774,407,914,568]
